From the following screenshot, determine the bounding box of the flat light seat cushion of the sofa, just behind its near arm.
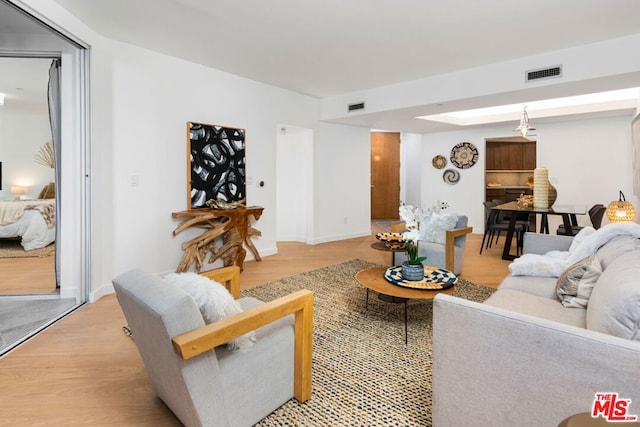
[484,288,586,328]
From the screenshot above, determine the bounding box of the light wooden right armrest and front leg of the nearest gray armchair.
[173,290,313,402]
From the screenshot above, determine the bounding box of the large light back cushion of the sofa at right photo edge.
[587,250,640,341]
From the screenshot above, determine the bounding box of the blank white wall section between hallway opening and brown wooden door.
[310,123,371,244]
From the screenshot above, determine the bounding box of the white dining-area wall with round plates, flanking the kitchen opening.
[421,116,640,233]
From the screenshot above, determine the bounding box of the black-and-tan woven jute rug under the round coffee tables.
[243,260,494,426]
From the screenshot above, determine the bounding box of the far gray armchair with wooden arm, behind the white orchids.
[393,215,473,274]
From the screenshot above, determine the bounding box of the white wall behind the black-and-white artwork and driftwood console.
[103,42,318,294]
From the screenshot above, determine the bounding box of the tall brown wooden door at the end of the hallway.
[371,132,400,219]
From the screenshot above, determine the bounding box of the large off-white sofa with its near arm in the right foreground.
[433,226,640,427]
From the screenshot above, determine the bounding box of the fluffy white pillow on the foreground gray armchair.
[164,273,256,353]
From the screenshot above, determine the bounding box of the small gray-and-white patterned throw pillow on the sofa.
[556,255,602,308]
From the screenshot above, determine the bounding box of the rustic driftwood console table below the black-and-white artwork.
[171,206,264,273]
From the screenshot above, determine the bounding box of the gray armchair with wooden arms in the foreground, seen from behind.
[113,266,313,426]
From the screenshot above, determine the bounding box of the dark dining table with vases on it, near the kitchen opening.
[491,201,587,260]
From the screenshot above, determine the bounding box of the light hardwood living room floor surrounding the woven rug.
[0,229,508,426]
